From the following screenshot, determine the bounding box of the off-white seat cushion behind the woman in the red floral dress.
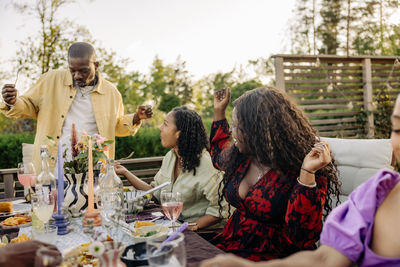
[321,137,393,200]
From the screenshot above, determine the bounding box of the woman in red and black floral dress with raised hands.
[210,87,340,261]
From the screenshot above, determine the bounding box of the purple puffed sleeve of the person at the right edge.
[321,170,400,262]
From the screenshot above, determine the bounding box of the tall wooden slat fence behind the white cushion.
[274,55,400,138]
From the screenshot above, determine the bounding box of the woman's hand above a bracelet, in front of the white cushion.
[301,141,332,173]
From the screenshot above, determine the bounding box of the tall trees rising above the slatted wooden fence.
[290,0,400,55]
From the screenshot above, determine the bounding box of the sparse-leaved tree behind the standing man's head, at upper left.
[14,0,91,79]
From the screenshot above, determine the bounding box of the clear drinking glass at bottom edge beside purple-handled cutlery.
[146,233,186,267]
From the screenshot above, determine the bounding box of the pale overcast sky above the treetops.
[0,0,295,81]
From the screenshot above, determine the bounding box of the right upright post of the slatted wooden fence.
[362,58,375,138]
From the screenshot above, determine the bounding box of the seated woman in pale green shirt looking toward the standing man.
[115,107,227,230]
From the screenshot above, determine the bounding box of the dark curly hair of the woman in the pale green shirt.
[172,107,209,175]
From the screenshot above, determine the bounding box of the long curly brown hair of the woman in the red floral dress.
[219,87,340,219]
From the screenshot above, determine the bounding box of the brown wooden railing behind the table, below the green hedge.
[0,157,164,199]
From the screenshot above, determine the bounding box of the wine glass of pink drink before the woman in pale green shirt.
[160,190,183,232]
